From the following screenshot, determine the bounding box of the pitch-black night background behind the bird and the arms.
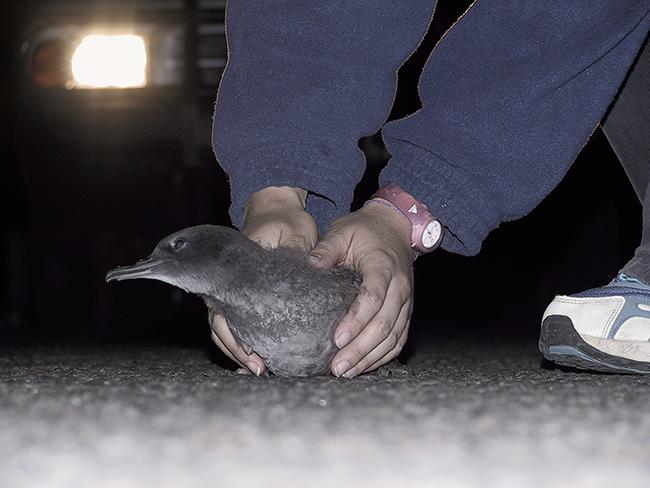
[0,0,641,350]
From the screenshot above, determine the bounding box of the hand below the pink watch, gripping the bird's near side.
[311,202,413,378]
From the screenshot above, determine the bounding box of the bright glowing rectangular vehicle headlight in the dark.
[72,35,147,88]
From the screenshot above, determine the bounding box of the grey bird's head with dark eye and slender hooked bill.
[106,225,251,294]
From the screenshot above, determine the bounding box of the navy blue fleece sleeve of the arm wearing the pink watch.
[380,0,650,255]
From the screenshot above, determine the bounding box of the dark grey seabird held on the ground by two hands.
[106,224,361,377]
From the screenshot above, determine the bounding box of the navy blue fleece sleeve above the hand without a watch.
[213,0,435,231]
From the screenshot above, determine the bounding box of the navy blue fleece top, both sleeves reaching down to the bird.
[213,0,650,255]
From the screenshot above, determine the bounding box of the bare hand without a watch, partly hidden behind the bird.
[210,186,318,376]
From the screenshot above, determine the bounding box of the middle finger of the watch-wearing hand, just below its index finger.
[332,276,404,376]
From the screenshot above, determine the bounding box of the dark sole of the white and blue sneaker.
[539,315,650,374]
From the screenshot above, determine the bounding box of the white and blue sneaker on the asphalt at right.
[539,274,650,373]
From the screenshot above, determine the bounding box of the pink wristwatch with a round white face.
[366,183,443,254]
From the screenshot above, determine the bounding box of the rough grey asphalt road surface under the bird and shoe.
[0,339,650,488]
